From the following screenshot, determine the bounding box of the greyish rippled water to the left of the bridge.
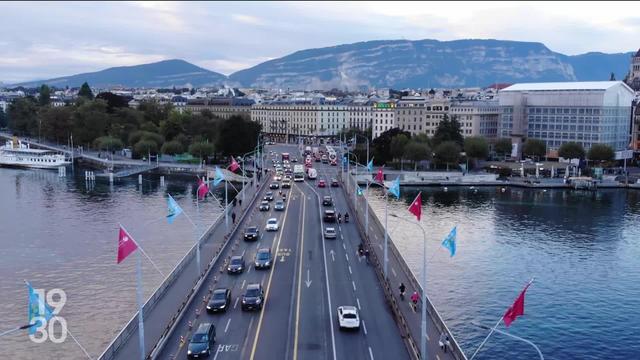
[0,168,229,359]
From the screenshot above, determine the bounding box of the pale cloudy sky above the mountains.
[0,1,640,83]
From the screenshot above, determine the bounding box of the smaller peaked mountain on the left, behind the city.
[15,60,228,88]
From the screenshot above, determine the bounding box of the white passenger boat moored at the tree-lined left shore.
[0,138,71,169]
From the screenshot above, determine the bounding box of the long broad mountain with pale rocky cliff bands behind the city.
[229,40,632,89]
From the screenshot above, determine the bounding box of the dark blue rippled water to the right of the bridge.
[373,187,640,359]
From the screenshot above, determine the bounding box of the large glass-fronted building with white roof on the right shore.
[498,81,634,157]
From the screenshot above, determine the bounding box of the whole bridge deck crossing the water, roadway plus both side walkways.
[100,145,466,360]
